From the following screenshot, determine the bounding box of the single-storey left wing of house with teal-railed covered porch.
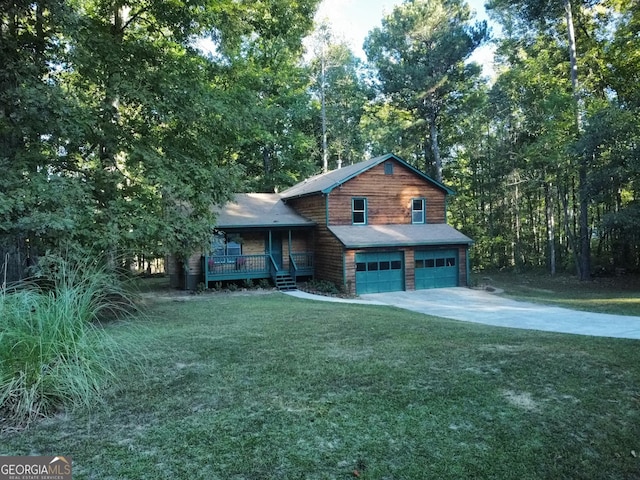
[168,193,315,290]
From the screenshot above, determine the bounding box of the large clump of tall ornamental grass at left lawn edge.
[0,261,134,428]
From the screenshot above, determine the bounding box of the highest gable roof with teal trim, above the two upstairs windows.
[281,153,454,200]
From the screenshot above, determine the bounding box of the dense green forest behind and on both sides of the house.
[0,0,640,279]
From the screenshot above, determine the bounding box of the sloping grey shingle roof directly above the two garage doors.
[329,223,473,248]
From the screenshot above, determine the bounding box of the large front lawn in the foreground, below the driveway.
[0,293,640,480]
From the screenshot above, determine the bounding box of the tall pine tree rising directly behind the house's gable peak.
[365,0,487,181]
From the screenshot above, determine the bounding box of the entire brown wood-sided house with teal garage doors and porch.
[168,154,473,294]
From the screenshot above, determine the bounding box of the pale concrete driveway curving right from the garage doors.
[292,287,640,339]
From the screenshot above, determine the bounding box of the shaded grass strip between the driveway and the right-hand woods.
[473,271,640,316]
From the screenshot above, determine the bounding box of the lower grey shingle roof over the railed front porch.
[215,193,315,228]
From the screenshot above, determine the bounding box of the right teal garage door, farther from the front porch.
[415,249,458,290]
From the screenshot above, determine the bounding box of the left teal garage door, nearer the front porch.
[356,252,404,295]
